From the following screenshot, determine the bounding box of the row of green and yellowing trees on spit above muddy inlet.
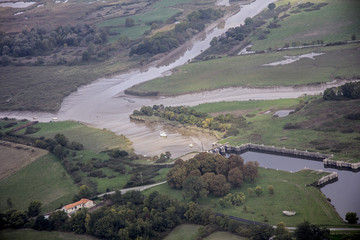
[133,105,246,136]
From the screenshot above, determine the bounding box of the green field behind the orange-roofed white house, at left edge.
[0,154,78,213]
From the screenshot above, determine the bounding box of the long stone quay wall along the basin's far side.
[208,143,360,171]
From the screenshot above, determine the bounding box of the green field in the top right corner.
[250,0,360,51]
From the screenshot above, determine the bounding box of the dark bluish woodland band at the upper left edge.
[0,25,107,57]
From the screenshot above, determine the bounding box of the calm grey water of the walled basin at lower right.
[241,152,360,219]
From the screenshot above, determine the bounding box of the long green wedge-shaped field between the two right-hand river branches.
[126,44,360,95]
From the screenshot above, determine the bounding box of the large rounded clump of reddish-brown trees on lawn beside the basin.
[167,153,258,201]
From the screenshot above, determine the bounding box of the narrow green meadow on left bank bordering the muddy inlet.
[23,121,131,152]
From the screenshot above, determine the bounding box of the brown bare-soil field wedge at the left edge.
[0,141,48,180]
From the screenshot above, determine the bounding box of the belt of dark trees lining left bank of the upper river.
[130,8,223,56]
